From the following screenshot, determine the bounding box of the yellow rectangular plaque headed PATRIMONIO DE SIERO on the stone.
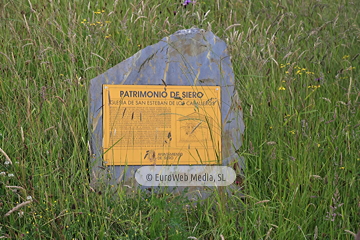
[103,85,221,165]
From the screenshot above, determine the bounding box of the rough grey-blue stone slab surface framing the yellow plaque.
[89,28,245,195]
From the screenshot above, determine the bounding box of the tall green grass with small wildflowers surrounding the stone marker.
[0,0,360,239]
